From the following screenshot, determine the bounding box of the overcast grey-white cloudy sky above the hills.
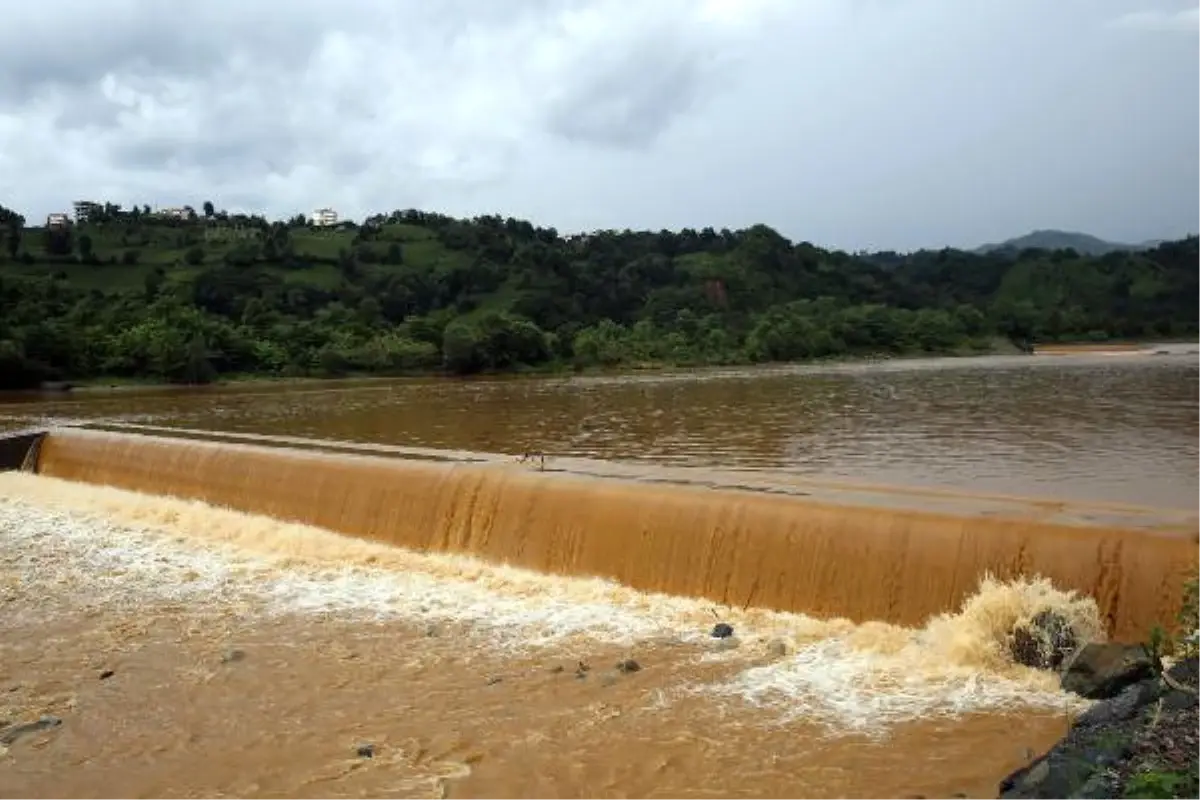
[0,0,1200,249]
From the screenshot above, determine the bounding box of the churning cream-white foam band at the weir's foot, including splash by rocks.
[0,473,1103,735]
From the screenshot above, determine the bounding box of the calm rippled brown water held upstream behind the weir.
[0,345,1200,509]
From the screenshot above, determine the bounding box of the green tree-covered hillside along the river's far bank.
[0,203,1200,387]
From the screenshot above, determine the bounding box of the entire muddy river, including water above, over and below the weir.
[0,356,1200,798]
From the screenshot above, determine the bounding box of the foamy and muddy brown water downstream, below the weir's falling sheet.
[0,473,1098,799]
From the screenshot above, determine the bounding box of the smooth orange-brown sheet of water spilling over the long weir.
[16,428,1200,638]
